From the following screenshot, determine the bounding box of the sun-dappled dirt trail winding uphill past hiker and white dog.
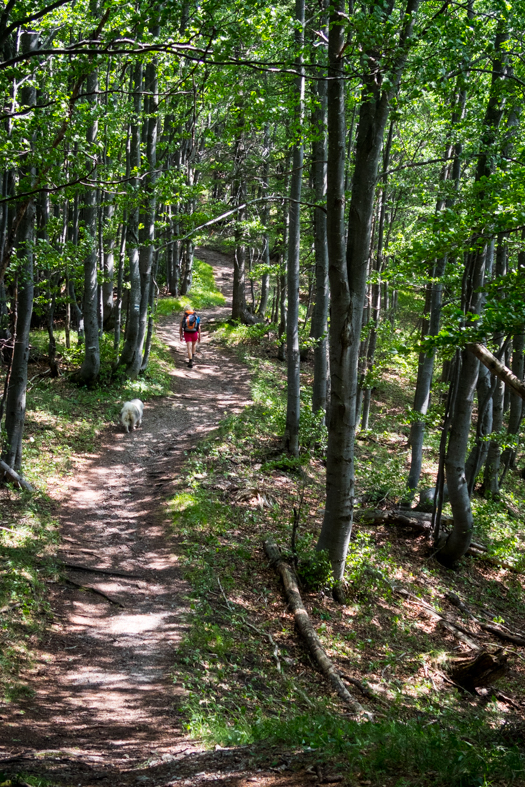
[0,250,302,786]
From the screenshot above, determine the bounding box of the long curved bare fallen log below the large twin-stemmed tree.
[263,539,373,720]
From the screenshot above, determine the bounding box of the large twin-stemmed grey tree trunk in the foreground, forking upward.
[317,0,419,583]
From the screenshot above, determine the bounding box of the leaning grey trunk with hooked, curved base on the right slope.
[438,29,507,566]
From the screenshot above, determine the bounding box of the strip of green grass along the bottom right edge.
[186,708,525,787]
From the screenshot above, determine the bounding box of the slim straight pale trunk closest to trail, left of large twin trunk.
[284,0,304,456]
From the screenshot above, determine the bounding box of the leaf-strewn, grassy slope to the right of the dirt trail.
[171,326,525,787]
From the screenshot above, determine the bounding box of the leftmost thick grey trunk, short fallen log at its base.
[2,31,38,471]
